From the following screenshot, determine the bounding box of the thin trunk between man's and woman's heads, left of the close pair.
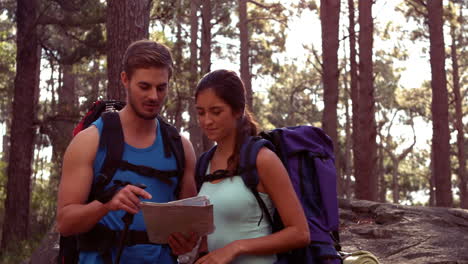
[188,1,203,157]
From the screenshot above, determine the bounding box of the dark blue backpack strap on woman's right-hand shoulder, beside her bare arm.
[239,137,275,225]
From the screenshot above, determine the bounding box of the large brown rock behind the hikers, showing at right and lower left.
[26,199,468,264]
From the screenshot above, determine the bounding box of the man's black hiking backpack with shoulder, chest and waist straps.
[58,100,185,264]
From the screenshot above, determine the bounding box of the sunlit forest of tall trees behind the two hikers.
[0,0,468,263]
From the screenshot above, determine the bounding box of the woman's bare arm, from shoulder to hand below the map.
[196,148,310,263]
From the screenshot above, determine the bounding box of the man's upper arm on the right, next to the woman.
[178,136,197,199]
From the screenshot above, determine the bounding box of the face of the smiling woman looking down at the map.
[196,88,239,143]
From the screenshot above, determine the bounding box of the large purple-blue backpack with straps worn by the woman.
[195,126,341,264]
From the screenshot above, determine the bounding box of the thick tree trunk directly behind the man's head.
[106,0,152,101]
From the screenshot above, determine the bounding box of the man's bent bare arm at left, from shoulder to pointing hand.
[57,126,151,236]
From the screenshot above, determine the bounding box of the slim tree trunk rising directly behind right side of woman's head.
[239,0,253,111]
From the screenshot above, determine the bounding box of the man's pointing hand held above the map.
[104,184,152,214]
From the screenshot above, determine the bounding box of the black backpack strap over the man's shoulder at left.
[89,112,124,200]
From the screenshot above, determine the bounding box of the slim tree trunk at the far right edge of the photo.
[451,23,468,209]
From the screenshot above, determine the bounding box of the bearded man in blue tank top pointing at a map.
[57,40,196,263]
